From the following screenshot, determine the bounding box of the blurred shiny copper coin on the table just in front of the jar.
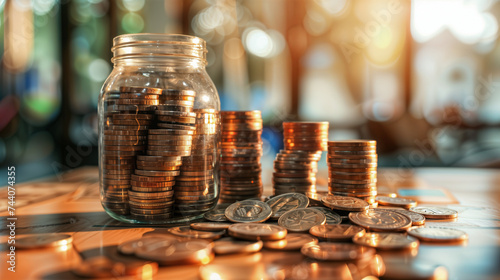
[135,239,213,265]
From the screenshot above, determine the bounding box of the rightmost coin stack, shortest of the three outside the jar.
[327,140,377,207]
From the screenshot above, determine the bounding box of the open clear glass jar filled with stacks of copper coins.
[98,34,220,224]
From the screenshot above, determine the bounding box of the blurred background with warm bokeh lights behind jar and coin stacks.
[0,0,500,182]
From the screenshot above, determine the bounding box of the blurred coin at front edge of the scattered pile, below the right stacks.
[300,242,375,261]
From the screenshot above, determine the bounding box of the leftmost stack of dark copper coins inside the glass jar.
[100,87,162,215]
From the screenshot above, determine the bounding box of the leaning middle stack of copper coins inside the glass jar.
[129,89,196,221]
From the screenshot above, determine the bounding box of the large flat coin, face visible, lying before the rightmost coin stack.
[349,209,412,231]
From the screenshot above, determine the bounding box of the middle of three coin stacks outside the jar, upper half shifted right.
[273,122,328,195]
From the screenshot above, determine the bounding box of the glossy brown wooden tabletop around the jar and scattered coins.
[0,167,500,280]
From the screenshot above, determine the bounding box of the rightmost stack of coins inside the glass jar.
[174,109,219,216]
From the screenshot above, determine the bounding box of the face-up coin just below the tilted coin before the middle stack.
[278,208,326,232]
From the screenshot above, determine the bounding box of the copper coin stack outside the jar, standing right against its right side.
[220,111,262,203]
